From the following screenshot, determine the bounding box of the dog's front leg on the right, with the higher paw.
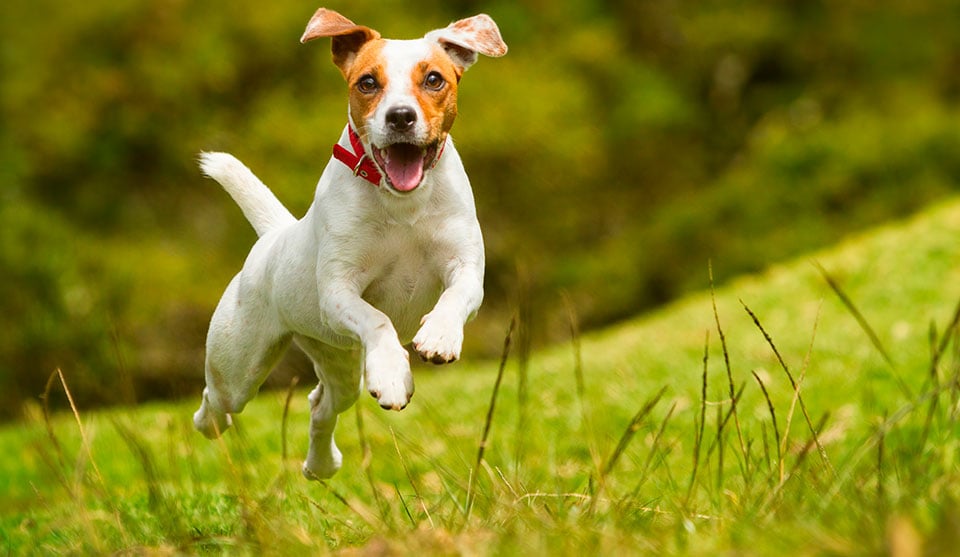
[413,261,483,364]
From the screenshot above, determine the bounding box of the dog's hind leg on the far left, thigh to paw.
[193,275,292,439]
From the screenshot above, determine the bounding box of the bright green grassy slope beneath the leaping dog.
[0,198,960,555]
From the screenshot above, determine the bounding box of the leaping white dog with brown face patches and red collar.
[193,8,507,480]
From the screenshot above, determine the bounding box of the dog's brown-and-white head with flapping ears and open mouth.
[300,8,507,193]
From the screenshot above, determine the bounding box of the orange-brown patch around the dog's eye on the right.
[410,46,461,141]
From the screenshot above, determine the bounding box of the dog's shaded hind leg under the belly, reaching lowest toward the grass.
[297,338,361,480]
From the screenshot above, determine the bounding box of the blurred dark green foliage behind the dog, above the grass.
[0,0,960,418]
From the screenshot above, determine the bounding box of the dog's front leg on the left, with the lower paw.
[321,288,413,410]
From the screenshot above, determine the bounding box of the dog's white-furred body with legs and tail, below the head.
[194,26,492,479]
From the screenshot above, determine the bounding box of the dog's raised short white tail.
[200,153,297,236]
